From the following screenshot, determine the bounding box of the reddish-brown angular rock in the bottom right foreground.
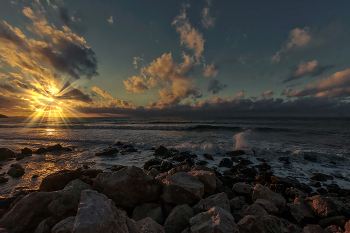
[306,195,340,218]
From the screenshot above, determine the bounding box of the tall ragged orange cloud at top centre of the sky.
[172,7,204,64]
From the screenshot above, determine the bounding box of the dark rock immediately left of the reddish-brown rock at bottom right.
[287,201,316,224]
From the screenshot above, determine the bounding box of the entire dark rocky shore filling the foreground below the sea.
[0,145,350,233]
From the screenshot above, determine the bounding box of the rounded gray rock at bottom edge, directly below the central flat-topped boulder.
[164,204,195,233]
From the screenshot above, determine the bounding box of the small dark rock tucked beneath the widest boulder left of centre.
[132,203,164,224]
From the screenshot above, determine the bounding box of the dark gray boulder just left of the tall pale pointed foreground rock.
[48,180,92,219]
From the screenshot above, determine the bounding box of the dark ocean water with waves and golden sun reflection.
[0,117,350,196]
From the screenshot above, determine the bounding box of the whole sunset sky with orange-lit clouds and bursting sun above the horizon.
[0,0,350,116]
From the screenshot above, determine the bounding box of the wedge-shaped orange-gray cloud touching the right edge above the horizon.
[288,69,350,98]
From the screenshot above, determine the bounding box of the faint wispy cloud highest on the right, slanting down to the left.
[271,27,311,62]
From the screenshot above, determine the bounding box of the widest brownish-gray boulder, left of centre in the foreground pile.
[94,166,161,208]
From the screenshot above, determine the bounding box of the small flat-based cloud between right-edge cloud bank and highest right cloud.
[283,60,334,83]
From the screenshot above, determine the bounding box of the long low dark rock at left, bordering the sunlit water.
[39,169,102,192]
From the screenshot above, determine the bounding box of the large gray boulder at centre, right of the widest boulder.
[163,172,204,205]
